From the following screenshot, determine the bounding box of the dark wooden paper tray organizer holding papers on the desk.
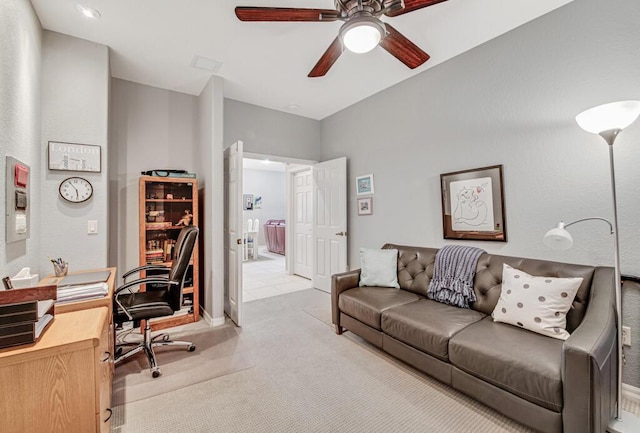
[0,286,56,349]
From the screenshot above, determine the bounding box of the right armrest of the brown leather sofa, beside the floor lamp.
[562,267,618,433]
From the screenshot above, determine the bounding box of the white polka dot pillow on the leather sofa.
[491,264,582,340]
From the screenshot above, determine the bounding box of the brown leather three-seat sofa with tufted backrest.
[331,244,617,433]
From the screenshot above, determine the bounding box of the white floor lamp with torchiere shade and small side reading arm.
[544,101,640,433]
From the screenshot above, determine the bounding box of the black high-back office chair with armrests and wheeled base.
[113,226,198,377]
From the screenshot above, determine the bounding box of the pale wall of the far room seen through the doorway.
[242,169,287,245]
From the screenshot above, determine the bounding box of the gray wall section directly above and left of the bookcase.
[109,78,198,280]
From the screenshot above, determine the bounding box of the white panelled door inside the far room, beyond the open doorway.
[292,168,313,279]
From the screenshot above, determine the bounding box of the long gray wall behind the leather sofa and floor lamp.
[321,0,640,386]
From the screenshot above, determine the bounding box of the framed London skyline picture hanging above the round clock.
[48,141,102,173]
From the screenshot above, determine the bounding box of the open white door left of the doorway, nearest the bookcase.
[224,141,244,326]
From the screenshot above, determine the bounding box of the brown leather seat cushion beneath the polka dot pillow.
[449,317,563,412]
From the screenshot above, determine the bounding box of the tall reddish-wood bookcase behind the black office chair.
[139,176,200,330]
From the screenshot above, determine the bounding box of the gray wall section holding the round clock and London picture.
[38,31,111,273]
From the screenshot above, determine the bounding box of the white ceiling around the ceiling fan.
[31,0,572,119]
